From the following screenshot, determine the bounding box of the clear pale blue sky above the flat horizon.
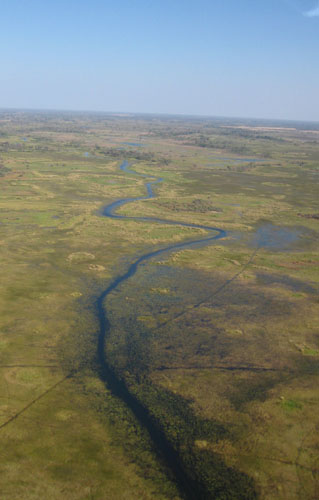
[0,0,319,121]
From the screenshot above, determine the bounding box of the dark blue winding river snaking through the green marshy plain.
[97,161,226,500]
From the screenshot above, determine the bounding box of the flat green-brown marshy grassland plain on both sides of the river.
[0,111,319,500]
